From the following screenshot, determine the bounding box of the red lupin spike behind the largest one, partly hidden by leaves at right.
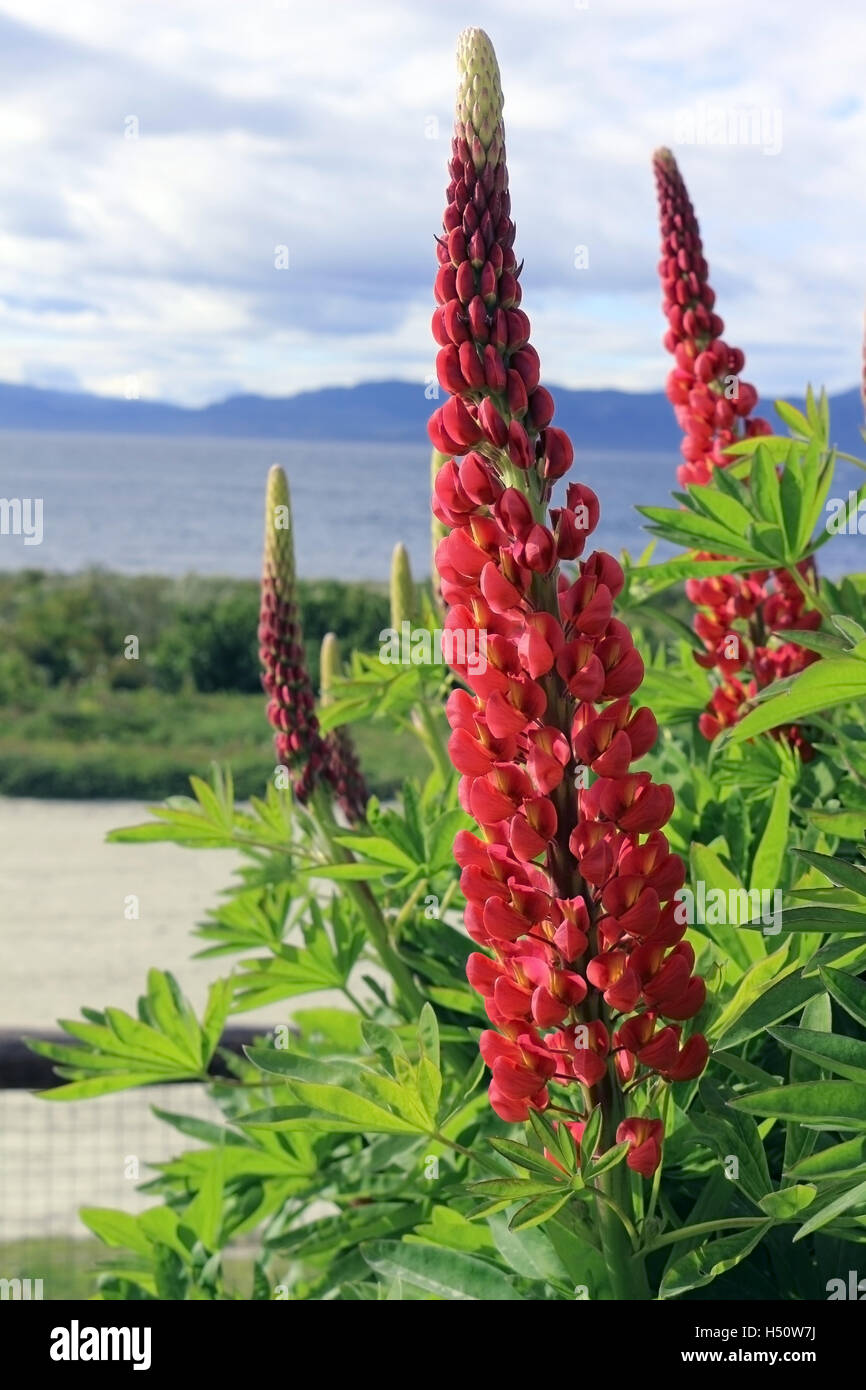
[653,149,820,758]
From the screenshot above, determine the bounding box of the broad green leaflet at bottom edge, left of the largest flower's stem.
[361,1240,521,1302]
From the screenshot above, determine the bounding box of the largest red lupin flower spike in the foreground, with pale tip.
[430,29,708,1173]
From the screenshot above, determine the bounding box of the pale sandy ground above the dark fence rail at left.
[0,798,247,1029]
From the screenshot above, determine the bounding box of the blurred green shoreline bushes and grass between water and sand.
[0,569,687,801]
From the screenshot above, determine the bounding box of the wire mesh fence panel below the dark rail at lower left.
[0,1030,249,1300]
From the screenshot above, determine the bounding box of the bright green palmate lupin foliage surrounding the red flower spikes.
[22,393,866,1301]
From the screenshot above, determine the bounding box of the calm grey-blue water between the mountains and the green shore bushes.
[0,432,676,580]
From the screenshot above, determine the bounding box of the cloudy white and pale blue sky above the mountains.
[0,0,866,404]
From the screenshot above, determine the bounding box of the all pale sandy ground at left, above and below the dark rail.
[0,798,286,1239]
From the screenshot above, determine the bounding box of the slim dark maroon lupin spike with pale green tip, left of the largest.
[259,464,328,801]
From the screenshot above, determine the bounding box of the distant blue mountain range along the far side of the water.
[0,381,863,452]
